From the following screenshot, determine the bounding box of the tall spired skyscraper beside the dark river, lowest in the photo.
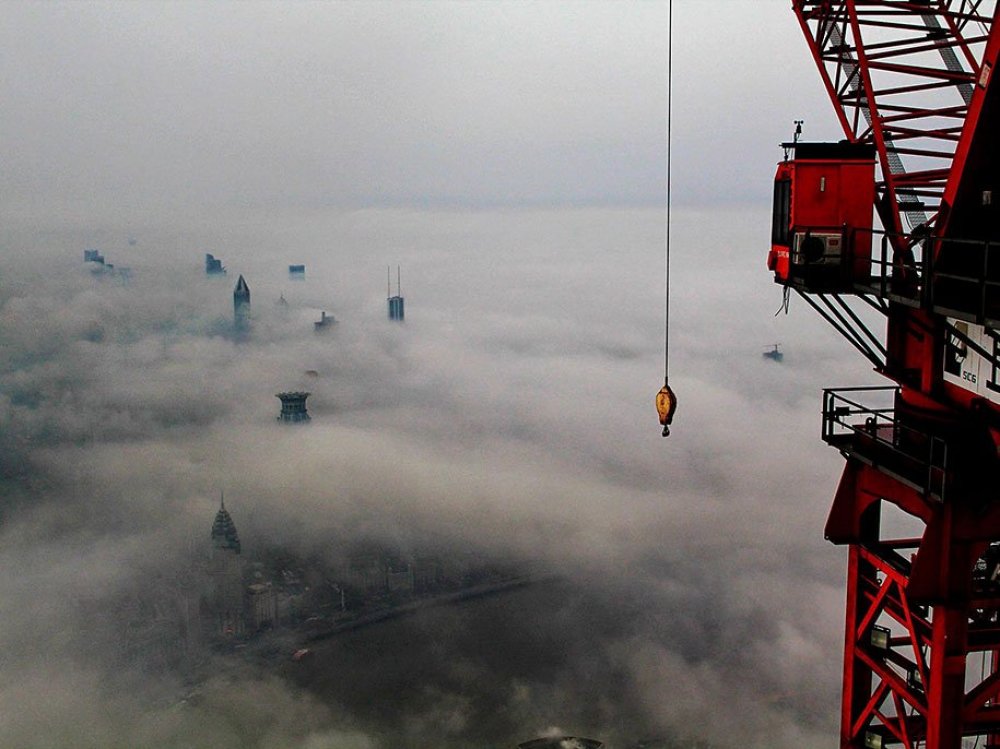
[207,495,245,637]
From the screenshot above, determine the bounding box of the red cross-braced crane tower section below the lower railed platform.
[826,446,1000,749]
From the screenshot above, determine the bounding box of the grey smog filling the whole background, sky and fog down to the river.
[0,0,874,749]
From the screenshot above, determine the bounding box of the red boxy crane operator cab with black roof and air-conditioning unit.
[767,141,875,293]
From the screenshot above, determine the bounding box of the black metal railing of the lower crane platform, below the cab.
[823,387,948,502]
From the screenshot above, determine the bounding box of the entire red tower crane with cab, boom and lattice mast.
[768,0,1000,749]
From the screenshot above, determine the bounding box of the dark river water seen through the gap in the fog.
[285,580,651,748]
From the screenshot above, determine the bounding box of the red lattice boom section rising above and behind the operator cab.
[794,0,995,234]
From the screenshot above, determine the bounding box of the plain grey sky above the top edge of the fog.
[0,0,836,214]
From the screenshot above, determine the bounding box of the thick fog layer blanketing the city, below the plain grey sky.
[0,209,880,747]
